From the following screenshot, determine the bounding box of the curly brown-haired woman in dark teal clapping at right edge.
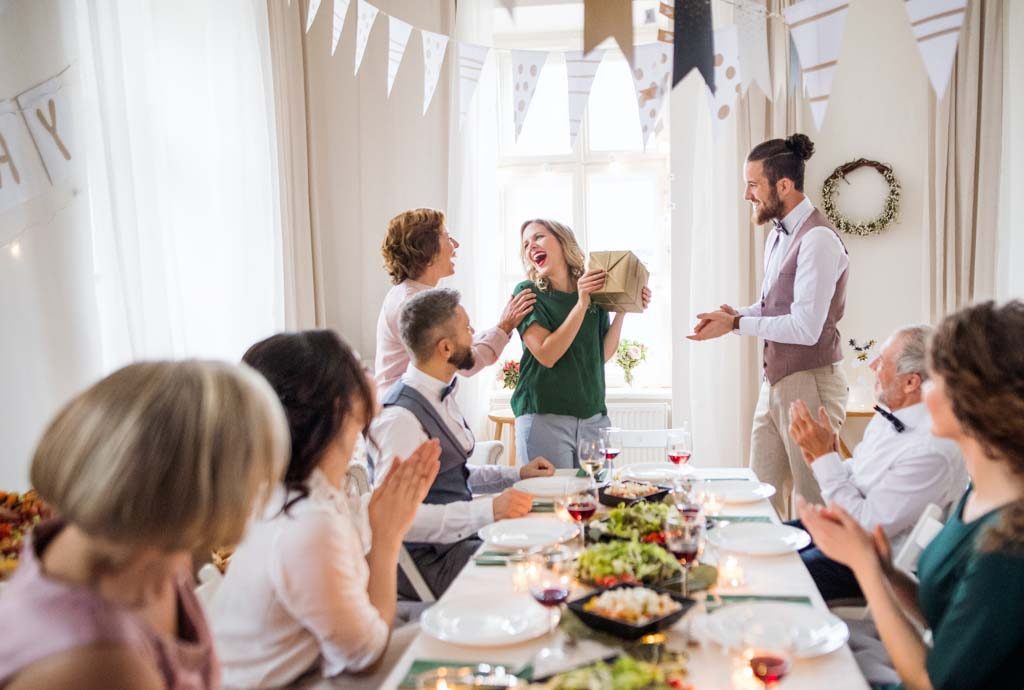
[800,300,1024,690]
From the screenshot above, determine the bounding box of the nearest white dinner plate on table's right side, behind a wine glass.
[706,601,850,658]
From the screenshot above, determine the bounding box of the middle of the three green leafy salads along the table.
[577,542,682,587]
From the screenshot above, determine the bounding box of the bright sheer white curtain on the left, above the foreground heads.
[77,0,284,368]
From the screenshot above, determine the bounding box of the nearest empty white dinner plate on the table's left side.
[420,596,549,647]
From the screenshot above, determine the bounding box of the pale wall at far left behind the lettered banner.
[0,0,101,490]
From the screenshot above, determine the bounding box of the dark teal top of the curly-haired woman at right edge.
[880,489,1024,690]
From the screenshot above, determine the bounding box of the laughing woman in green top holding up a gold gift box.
[512,220,650,468]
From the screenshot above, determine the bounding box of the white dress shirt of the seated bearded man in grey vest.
[370,363,519,544]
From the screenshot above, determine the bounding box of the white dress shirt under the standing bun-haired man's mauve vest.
[736,197,850,345]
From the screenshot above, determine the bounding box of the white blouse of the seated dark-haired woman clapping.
[209,470,389,688]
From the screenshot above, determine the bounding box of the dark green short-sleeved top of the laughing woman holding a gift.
[512,281,610,419]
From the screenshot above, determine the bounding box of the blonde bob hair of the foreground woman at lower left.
[31,360,289,551]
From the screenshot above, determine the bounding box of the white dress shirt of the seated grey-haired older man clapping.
[811,402,967,554]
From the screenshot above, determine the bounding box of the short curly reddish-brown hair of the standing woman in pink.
[381,209,444,285]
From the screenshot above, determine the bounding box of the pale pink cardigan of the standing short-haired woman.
[374,281,509,397]
